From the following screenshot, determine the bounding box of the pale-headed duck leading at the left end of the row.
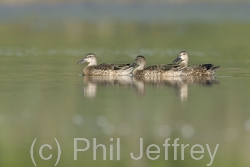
[77,53,134,76]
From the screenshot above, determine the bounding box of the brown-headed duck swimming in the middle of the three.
[130,55,181,77]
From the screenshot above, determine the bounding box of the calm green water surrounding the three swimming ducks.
[0,4,250,167]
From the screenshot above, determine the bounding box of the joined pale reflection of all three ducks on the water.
[83,76,219,101]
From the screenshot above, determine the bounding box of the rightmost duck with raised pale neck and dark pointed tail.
[173,51,220,76]
